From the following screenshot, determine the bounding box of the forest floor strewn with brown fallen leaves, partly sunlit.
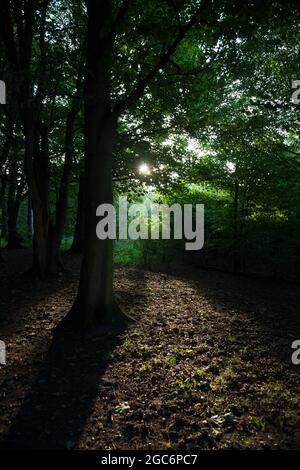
[0,250,300,450]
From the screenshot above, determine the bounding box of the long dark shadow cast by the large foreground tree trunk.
[2,327,123,449]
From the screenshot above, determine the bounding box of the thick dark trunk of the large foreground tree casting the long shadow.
[69,0,121,325]
